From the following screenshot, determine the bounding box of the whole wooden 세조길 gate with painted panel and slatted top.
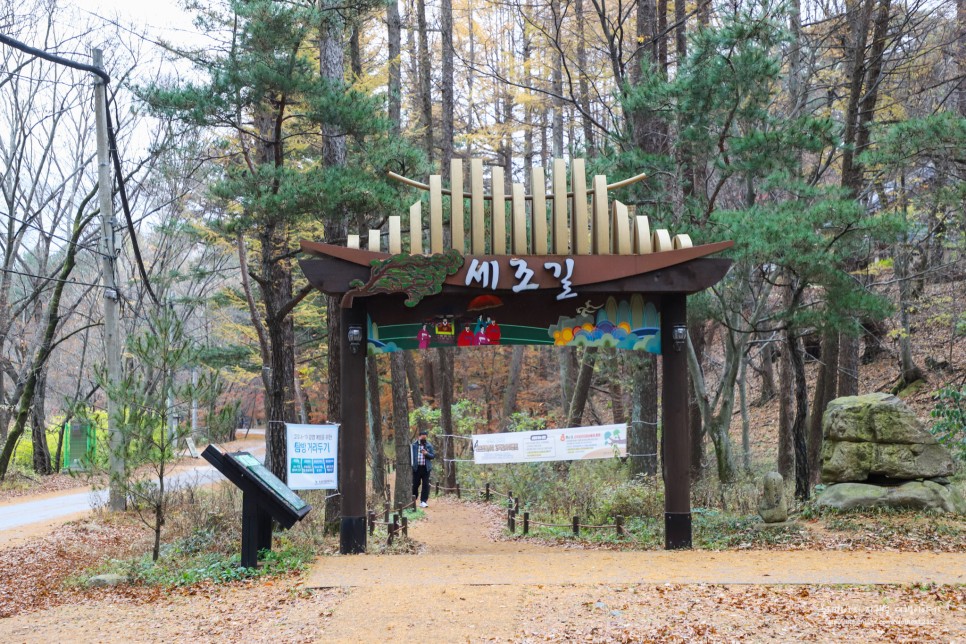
[300,159,732,553]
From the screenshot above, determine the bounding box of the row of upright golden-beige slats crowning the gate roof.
[347,158,692,255]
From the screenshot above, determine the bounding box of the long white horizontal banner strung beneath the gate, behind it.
[473,425,627,465]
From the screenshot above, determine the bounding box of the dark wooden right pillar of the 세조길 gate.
[661,293,691,550]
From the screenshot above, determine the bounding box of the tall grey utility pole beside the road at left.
[91,49,127,511]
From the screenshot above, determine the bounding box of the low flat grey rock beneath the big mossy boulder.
[815,481,966,514]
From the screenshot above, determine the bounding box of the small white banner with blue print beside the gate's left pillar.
[285,423,339,490]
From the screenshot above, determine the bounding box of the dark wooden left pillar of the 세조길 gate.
[339,298,368,555]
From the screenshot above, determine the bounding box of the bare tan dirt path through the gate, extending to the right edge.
[306,499,966,642]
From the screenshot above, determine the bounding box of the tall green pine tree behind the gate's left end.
[142,0,422,477]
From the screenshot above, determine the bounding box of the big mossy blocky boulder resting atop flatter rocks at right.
[822,393,955,483]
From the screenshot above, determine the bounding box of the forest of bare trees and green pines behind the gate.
[0,0,966,515]
